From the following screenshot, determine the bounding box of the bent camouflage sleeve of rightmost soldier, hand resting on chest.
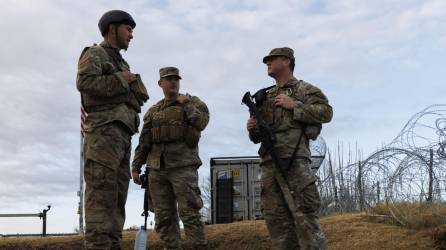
[293,85,333,123]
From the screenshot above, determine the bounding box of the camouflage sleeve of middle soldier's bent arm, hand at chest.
[184,96,209,131]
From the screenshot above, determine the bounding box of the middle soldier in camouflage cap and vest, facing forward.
[132,67,209,249]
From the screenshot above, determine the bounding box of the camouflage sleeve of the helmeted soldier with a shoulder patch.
[76,47,130,97]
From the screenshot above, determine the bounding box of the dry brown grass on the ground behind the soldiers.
[0,213,445,250]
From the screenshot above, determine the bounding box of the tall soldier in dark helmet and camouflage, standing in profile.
[77,10,149,249]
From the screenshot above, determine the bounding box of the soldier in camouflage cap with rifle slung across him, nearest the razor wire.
[247,47,333,250]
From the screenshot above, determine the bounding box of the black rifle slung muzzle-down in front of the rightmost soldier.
[242,89,314,247]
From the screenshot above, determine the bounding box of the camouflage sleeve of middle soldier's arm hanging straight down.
[132,110,152,172]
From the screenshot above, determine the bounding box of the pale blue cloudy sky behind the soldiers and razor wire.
[0,0,446,234]
